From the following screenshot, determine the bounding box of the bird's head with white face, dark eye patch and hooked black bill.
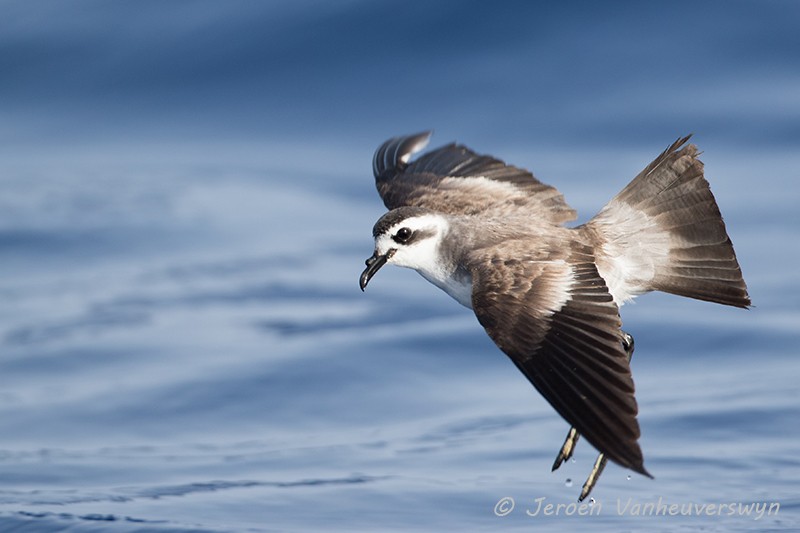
[361,214,449,290]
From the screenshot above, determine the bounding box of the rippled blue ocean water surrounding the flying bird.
[0,1,800,532]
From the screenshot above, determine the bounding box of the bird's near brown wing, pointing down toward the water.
[472,241,649,475]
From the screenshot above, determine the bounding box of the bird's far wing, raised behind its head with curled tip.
[373,132,576,224]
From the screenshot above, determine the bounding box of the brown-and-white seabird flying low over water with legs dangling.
[359,131,751,500]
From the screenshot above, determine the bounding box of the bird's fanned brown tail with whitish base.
[583,136,750,307]
